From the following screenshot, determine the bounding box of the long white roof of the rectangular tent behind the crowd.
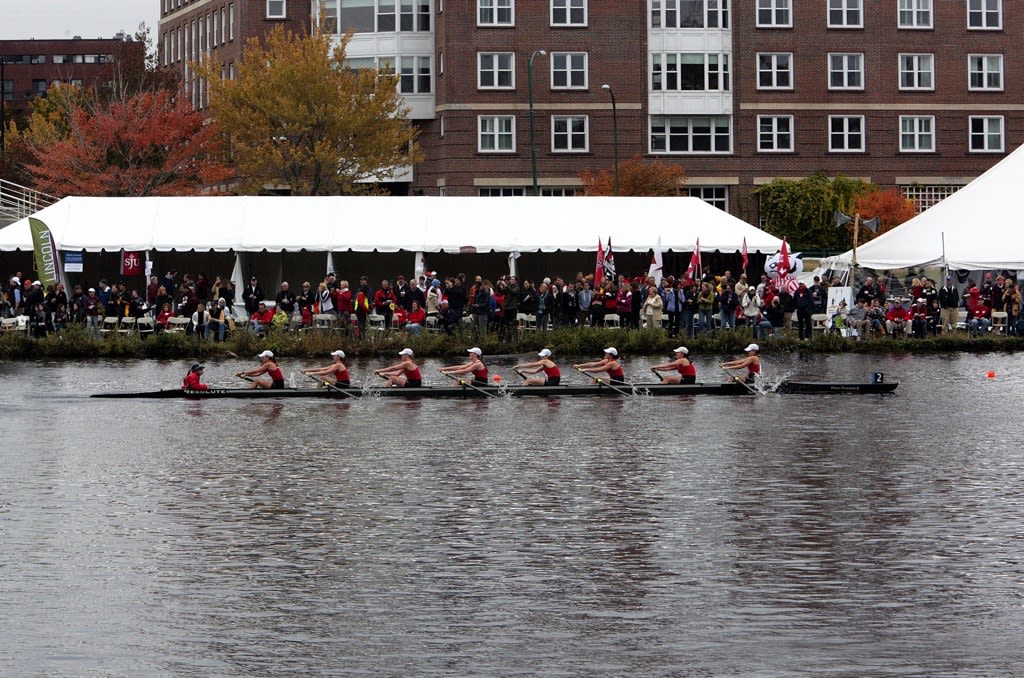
[0,197,781,253]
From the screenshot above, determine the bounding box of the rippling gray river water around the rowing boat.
[0,354,1024,676]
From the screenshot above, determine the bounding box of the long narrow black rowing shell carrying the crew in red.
[92,381,899,400]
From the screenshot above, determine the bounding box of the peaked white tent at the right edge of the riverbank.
[822,142,1024,270]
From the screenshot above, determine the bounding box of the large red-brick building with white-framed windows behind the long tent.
[155,0,1024,222]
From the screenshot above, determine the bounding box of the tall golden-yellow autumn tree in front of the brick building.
[196,28,421,196]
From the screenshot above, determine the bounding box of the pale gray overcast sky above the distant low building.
[0,0,160,44]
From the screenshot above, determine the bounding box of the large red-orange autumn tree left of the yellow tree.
[24,90,233,197]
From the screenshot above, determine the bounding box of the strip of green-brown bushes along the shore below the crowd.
[0,326,1024,361]
